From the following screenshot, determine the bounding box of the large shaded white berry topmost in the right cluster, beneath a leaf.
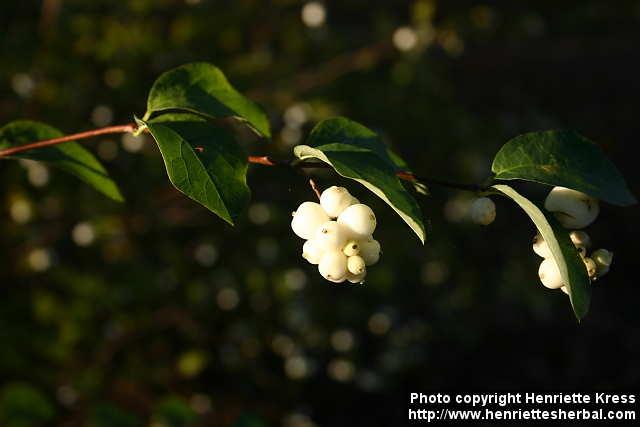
[544,187,600,229]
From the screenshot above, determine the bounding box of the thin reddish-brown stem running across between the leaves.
[0,123,487,193]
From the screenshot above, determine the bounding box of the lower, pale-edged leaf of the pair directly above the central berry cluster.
[294,143,425,243]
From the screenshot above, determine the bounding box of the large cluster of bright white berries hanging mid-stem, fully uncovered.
[291,186,381,283]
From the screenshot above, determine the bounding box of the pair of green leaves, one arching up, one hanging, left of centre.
[139,63,271,224]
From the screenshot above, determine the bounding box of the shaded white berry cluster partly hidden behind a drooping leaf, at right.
[533,187,613,293]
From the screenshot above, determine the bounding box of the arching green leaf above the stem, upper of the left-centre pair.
[144,62,271,138]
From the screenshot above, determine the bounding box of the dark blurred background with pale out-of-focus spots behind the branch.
[0,0,640,427]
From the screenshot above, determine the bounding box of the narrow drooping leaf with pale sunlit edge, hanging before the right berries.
[492,184,591,320]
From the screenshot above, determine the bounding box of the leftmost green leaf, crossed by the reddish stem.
[0,120,123,202]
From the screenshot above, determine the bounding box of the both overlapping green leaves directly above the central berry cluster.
[294,119,425,243]
